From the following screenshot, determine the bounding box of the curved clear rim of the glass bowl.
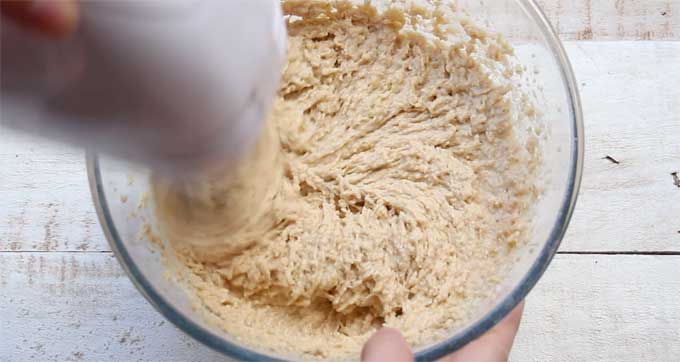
[86,0,584,361]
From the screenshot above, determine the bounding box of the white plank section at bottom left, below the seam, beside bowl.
[0,252,224,362]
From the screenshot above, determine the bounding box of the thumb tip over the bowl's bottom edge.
[361,328,413,362]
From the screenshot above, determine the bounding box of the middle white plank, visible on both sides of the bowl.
[0,42,680,251]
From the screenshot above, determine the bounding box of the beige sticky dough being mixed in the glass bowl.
[154,1,539,357]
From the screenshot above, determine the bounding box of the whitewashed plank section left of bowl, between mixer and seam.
[0,128,105,251]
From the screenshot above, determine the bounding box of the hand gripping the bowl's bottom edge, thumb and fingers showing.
[361,302,524,362]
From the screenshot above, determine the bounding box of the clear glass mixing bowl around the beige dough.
[87,0,583,360]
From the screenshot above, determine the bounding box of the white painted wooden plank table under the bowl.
[0,0,680,361]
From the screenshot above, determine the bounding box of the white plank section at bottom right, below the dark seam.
[511,255,680,362]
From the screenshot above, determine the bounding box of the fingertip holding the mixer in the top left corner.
[0,0,79,38]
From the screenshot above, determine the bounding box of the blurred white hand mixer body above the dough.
[0,0,286,174]
